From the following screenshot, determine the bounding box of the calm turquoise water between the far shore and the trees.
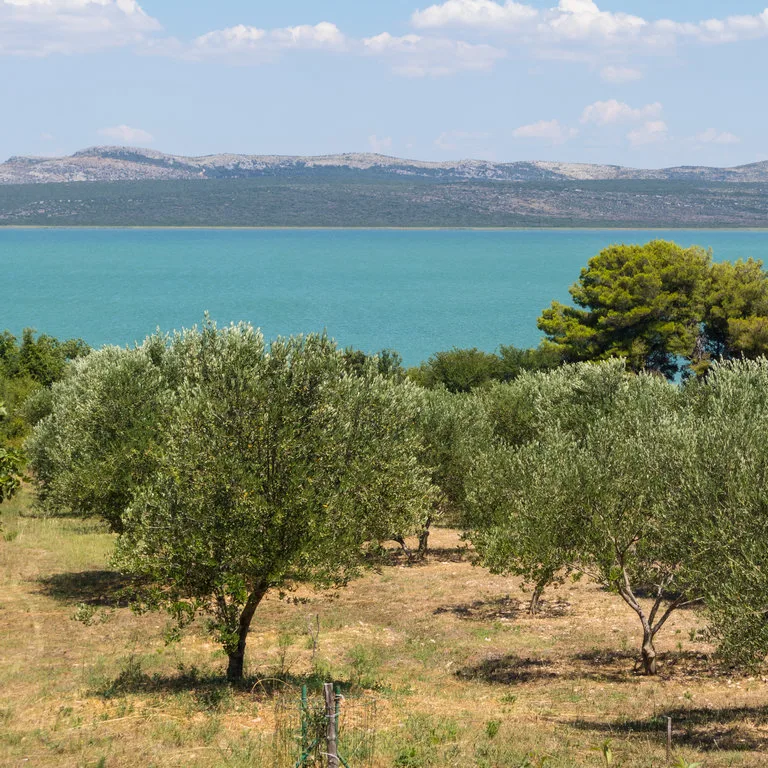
[0,229,768,365]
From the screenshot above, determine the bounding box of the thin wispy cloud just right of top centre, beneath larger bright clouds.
[363,32,506,77]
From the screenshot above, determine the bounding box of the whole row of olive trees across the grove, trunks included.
[22,321,768,679]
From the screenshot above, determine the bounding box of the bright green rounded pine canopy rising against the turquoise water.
[538,240,768,378]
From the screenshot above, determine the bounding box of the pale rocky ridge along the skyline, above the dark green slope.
[0,147,768,184]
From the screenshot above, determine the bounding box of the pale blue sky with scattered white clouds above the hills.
[0,0,768,168]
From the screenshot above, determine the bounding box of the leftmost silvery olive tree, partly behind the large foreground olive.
[27,342,171,533]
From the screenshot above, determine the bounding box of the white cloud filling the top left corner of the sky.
[0,0,161,56]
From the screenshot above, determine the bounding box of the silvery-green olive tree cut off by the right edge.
[681,359,768,666]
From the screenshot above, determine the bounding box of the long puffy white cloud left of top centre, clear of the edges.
[191,21,347,58]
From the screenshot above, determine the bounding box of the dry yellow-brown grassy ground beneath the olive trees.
[0,488,768,768]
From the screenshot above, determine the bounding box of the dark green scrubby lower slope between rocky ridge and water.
[0,177,768,227]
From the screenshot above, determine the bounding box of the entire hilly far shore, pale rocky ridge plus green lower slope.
[0,147,768,228]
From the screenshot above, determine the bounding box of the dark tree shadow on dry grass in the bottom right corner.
[569,706,768,751]
